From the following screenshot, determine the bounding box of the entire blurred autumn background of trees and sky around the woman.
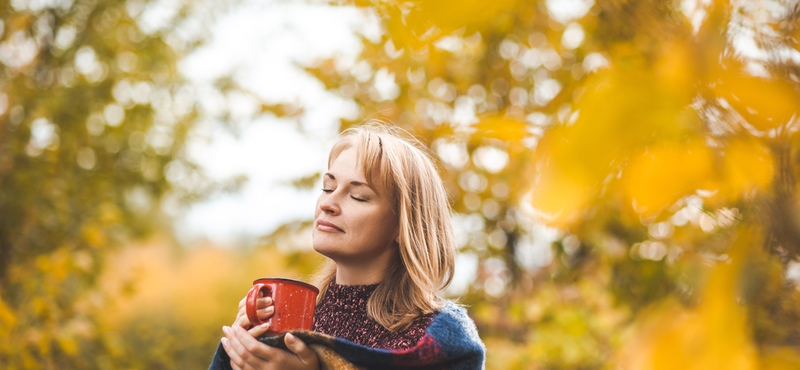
[0,0,800,370]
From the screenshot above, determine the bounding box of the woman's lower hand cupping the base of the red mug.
[221,325,319,370]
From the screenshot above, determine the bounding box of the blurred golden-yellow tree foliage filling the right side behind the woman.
[292,0,800,368]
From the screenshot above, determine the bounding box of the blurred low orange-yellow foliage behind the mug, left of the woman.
[95,238,323,369]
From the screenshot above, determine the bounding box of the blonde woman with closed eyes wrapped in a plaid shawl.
[211,124,485,370]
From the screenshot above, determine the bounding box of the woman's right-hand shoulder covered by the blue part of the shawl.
[427,301,486,364]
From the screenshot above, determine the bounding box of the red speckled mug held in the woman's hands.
[245,278,319,335]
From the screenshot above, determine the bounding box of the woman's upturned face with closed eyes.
[312,148,399,267]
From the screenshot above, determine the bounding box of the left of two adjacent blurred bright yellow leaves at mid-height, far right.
[623,141,713,213]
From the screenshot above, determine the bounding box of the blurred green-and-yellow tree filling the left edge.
[0,0,223,369]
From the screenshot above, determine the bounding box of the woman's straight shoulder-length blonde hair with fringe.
[317,122,456,331]
